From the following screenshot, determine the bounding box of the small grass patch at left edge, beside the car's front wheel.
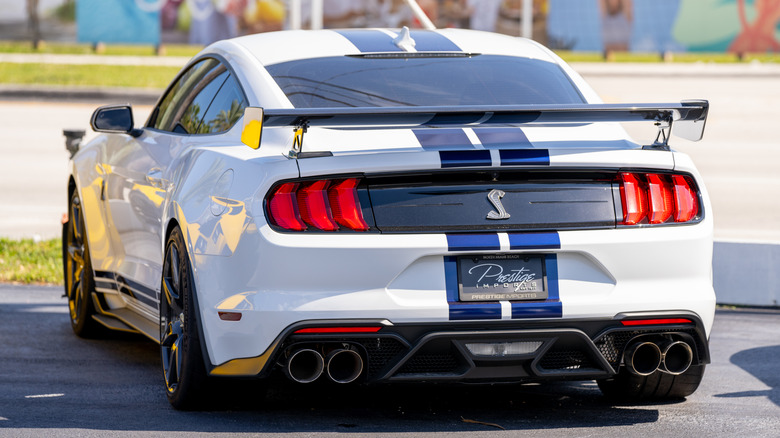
[0,237,62,284]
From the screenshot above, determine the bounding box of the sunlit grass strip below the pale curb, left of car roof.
[0,62,180,89]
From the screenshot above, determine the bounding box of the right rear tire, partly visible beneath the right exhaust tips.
[598,365,705,402]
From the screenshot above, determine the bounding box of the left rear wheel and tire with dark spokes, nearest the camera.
[160,227,210,410]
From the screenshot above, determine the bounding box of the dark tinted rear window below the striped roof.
[268,55,584,108]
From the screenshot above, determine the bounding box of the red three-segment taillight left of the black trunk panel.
[267,178,369,231]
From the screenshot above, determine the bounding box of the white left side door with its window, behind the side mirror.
[103,58,228,319]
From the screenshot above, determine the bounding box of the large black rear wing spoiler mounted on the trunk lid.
[241,100,709,157]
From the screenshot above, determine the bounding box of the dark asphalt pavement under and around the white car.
[0,285,780,438]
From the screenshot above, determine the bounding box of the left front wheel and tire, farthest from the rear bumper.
[62,190,106,338]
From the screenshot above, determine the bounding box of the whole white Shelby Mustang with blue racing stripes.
[63,29,715,408]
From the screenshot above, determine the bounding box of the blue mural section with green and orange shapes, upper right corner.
[547,0,780,53]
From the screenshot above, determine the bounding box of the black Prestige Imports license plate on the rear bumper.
[458,254,547,301]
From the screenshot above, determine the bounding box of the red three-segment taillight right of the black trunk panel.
[620,172,699,225]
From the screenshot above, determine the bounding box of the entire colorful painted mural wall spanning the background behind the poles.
[68,0,780,53]
